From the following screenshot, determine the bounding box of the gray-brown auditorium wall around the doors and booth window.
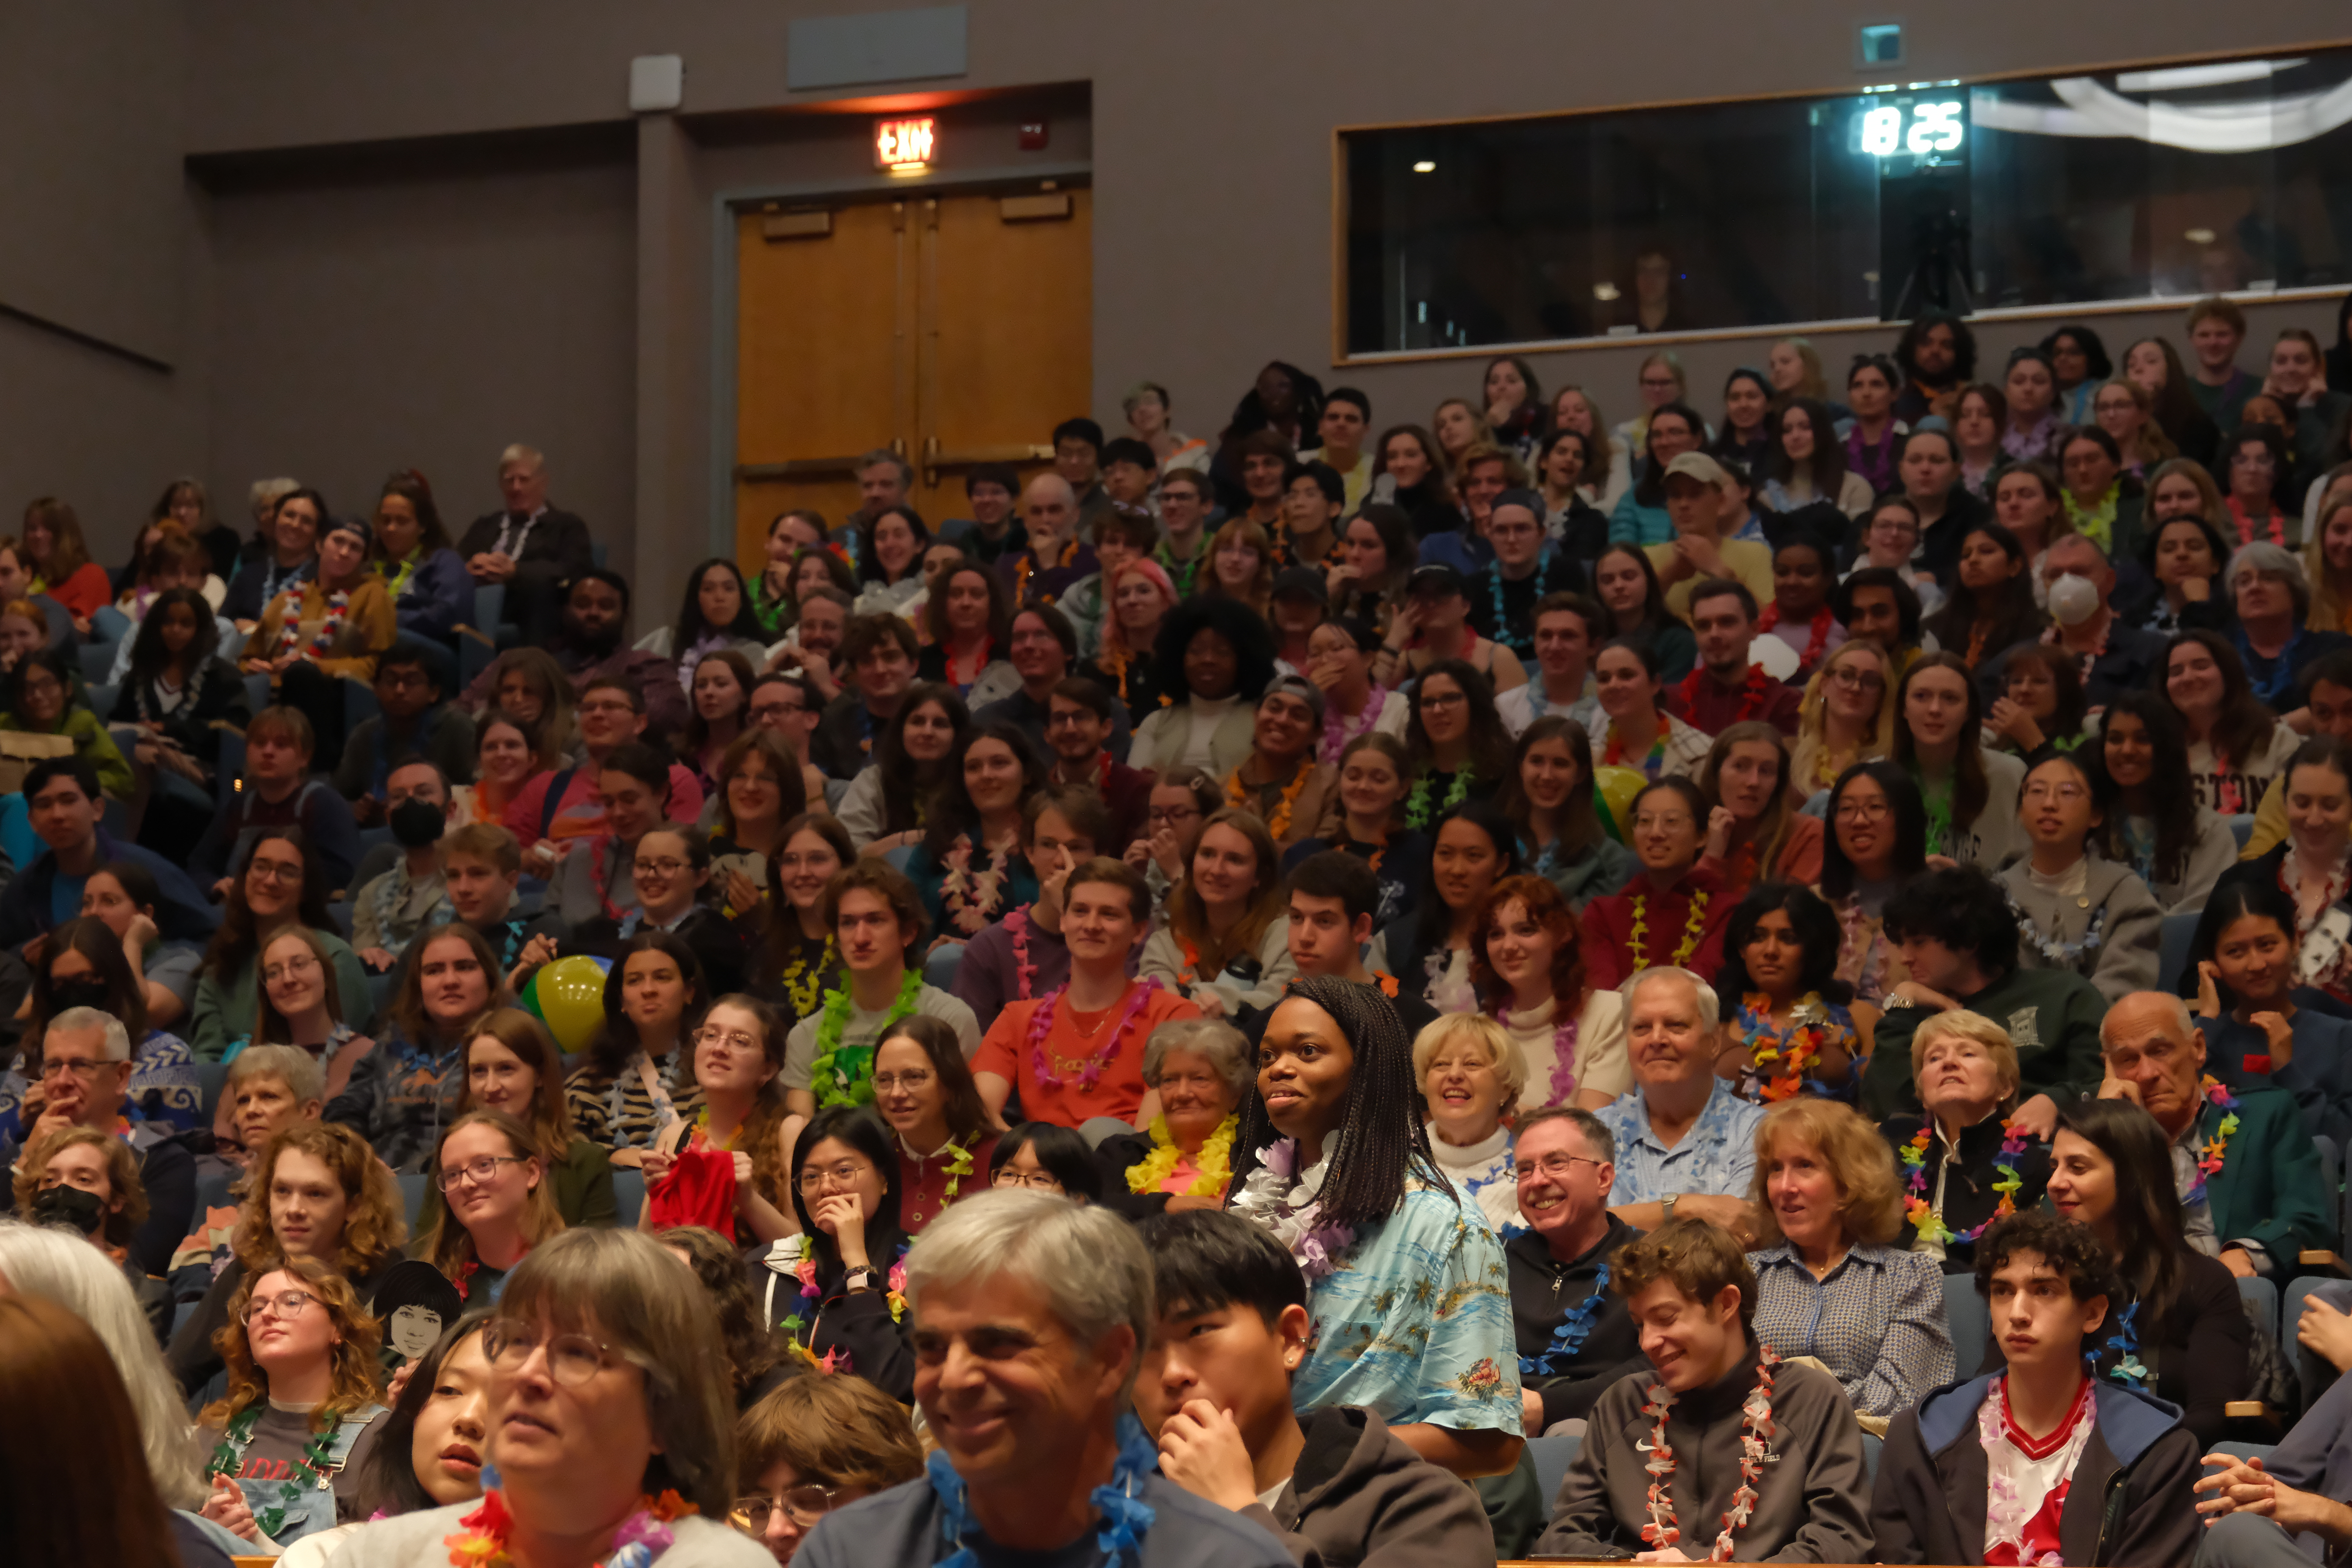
[0,0,2352,597]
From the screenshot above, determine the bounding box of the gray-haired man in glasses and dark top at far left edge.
[0,1006,195,1274]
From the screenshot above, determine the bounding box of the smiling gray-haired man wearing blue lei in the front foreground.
[793,1192,1291,1568]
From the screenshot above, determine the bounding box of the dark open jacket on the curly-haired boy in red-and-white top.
[1870,1377,2204,1568]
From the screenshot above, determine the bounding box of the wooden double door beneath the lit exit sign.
[734,186,1094,571]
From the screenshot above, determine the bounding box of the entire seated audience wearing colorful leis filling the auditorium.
[14,301,2352,1568]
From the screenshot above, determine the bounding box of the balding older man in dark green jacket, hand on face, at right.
[2098,992,2333,1281]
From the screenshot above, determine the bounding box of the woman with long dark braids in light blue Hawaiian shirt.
[1228,976,1522,1476]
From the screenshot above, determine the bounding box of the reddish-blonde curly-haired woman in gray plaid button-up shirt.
[1748,1095,1955,1432]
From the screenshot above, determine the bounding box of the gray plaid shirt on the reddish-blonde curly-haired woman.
[1748,1241,1955,1415]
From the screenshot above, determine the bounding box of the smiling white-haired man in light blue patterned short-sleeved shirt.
[1595,966,1764,1241]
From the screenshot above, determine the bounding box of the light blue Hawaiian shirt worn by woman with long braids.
[1291,1182,1522,1436]
